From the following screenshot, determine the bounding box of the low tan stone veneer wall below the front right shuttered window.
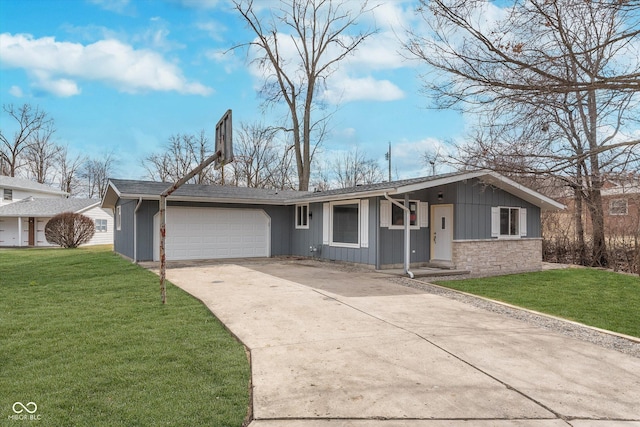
[452,239,542,276]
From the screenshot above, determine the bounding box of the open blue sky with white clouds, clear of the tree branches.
[0,0,464,179]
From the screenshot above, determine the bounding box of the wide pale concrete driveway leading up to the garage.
[167,263,640,427]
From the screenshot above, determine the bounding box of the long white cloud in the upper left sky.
[0,33,213,96]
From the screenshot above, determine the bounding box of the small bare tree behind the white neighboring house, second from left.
[24,122,62,184]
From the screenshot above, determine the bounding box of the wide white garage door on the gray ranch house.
[153,207,271,261]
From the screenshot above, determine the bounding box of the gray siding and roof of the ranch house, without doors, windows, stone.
[103,171,562,268]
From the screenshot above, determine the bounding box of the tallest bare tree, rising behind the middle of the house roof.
[234,0,374,191]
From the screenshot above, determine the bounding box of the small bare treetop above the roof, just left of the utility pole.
[333,147,384,188]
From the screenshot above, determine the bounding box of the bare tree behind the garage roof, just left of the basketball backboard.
[142,130,218,184]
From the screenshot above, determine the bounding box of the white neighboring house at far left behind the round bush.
[0,176,113,247]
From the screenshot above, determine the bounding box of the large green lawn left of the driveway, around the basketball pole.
[0,247,250,426]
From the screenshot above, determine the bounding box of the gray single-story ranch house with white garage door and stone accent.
[102,171,564,274]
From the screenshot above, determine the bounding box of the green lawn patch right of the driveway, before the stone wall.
[437,268,640,337]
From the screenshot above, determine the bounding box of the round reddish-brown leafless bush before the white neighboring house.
[44,212,96,248]
